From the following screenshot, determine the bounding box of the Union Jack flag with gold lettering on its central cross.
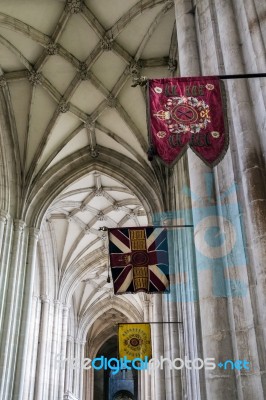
[109,227,169,294]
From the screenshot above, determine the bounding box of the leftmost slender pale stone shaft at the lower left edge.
[0,220,25,400]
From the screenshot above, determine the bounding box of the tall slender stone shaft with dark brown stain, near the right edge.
[215,1,266,349]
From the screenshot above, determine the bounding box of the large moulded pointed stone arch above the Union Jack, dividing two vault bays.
[23,146,163,228]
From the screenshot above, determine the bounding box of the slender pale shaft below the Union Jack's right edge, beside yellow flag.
[152,294,165,400]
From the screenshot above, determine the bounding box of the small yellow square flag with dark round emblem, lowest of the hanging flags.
[118,324,152,360]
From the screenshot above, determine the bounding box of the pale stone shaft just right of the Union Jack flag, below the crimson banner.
[168,162,206,400]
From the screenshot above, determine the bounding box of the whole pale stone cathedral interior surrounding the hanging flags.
[0,0,266,400]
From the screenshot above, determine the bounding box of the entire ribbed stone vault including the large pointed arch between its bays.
[0,0,177,382]
